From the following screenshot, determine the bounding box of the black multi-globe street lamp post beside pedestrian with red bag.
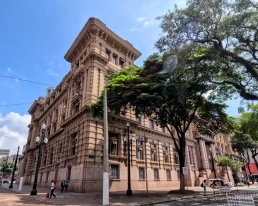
[30,124,48,195]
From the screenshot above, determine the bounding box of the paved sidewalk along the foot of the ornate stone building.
[2,184,257,206]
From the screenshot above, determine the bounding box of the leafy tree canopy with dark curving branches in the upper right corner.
[156,0,258,100]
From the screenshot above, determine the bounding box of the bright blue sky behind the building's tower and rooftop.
[0,0,239,154]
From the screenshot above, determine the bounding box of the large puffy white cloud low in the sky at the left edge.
[0,112,31,154]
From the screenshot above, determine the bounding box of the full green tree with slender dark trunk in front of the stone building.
[91,54,233,190]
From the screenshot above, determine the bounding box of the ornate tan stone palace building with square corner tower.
[20,18,240,192]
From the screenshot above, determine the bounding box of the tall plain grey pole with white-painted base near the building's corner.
[102,90,109,205]
